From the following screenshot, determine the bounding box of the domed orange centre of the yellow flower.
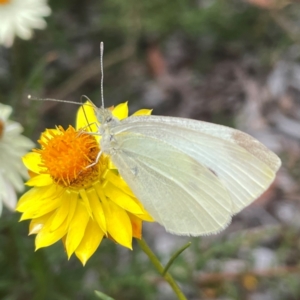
[35,126,107,187]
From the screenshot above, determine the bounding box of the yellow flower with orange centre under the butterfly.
[17,103,153,265]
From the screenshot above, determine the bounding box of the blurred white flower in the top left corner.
[0,0,51,47]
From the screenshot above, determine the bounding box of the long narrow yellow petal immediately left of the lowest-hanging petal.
[66,201,89,258]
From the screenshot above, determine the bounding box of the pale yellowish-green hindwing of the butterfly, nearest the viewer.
[111,132,232,236]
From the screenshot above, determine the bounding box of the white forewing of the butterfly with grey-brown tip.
[112,116,281,217]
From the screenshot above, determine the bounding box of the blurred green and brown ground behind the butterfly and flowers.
[0,0,300,300]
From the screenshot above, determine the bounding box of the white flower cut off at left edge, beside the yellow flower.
[0,103,34,215]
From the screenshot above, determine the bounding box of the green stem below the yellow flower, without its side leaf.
[136,239,187,300]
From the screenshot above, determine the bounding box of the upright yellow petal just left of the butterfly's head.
[76,101,99,132]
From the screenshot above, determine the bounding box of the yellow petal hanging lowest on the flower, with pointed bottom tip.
[75,219,104,265]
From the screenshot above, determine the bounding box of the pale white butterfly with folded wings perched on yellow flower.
[95,43,281,236]
